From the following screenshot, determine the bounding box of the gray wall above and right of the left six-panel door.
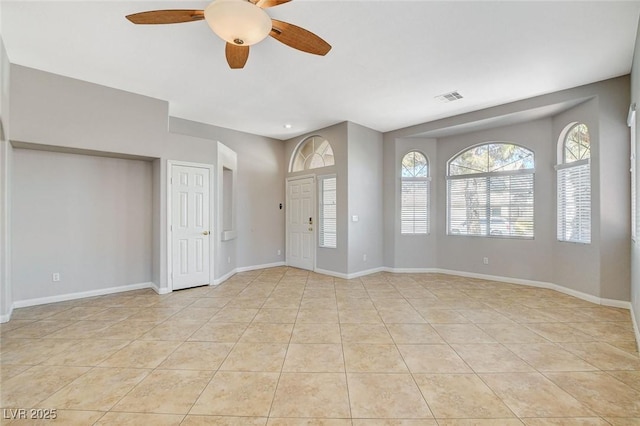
[167,117,286,277]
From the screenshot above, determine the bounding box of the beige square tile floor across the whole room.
[0,267,640,426]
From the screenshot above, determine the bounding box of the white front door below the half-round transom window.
[287,177,316,271]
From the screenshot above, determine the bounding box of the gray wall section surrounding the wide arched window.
[434,119,555,282]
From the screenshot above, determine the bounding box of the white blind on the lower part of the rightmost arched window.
[557,159,591,243]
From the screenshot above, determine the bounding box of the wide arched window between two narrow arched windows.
[447,142,535,238]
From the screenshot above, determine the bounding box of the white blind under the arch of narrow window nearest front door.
[400,178,430,234]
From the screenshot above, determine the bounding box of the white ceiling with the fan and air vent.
[0,0,640,139]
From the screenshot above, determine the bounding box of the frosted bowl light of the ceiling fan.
[204,0,272,46]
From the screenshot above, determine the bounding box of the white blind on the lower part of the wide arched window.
[447,173,534,238]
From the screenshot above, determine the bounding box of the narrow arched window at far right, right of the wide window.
[556,123,591,244]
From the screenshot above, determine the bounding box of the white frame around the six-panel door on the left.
[166,160,217,292]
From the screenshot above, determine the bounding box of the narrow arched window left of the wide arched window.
[400,151,430,234]
